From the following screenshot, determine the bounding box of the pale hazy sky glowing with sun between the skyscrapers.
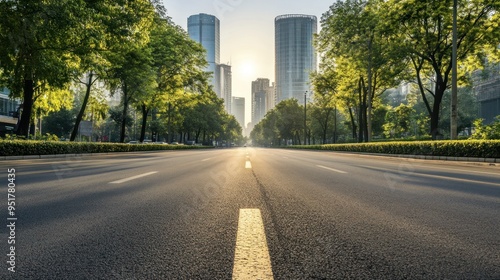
[163,0,335,123]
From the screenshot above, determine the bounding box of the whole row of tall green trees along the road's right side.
[311,0,500,142]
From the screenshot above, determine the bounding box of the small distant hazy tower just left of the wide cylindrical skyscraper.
[252,78,274,125]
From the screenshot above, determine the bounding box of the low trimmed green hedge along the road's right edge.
[291,140,500,158]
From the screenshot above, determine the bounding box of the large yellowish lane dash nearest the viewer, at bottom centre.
[233,209,274,279]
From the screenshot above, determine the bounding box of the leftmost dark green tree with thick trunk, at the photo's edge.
[0,0,82,136]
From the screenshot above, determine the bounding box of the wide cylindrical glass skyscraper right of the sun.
[274,15,318,102]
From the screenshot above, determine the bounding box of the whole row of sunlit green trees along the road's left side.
[0,0,241,142]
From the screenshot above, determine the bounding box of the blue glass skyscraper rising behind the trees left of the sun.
[188,14,221,96]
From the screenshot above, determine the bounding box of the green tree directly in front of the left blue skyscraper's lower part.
[145,15,209,142]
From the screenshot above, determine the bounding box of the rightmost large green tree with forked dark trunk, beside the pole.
[383,0,500,139]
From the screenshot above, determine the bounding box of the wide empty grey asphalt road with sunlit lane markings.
[0,148,500,279]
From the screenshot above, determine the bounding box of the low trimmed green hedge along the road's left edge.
[0,140,212,156]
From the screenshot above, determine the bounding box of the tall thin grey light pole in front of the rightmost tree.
[450,0,458,140]
